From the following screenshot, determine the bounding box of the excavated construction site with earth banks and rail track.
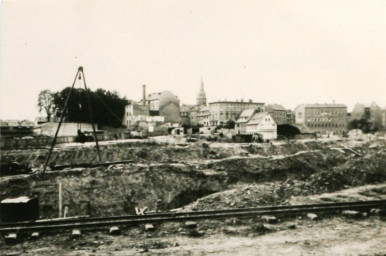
[0,135,386,255]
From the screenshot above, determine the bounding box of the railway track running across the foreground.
[0,200,386,233]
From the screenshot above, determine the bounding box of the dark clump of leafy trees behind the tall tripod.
[37,87,129,127]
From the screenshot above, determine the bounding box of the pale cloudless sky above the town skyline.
[0,0,386,120]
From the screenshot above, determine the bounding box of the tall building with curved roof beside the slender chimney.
[139,85,180,123]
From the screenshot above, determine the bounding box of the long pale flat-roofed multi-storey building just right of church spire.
[209,100,264,125]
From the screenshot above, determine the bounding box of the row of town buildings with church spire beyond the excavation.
[123,81,358,138]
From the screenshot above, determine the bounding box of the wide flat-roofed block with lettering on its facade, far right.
[294,104,347,134]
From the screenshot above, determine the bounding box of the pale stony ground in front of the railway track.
[0,216,386,256]
